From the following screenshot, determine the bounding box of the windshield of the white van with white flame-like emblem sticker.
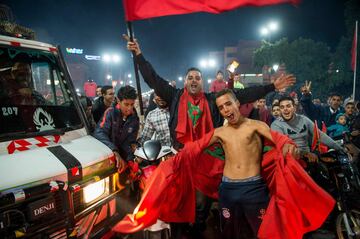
[0,46,82,141]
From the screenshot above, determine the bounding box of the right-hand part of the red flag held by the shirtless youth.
[258,131,335,239]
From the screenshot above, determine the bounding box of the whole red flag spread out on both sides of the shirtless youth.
[113,132,335,239]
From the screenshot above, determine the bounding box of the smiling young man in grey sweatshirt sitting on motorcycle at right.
[271,96,343,162]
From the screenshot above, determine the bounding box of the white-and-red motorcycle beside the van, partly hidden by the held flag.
[130,140,173,239]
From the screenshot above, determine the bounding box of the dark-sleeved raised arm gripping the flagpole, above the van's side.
[123,35,176,105]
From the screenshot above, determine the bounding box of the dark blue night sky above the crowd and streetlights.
[0,0,345,90]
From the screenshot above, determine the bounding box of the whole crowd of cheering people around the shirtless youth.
[76,37,360,238]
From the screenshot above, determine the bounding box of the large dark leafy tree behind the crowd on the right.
[254,38,332,99]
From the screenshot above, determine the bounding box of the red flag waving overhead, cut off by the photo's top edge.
[123,0,300,21]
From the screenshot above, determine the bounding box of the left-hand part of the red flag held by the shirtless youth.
[113,131,217,233]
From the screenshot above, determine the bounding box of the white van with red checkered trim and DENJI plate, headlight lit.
[0,35,121,239]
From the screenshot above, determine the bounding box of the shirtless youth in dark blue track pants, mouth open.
[209,89,297,239]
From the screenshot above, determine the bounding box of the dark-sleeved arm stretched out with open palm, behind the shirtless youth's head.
[234,75,296,104]
